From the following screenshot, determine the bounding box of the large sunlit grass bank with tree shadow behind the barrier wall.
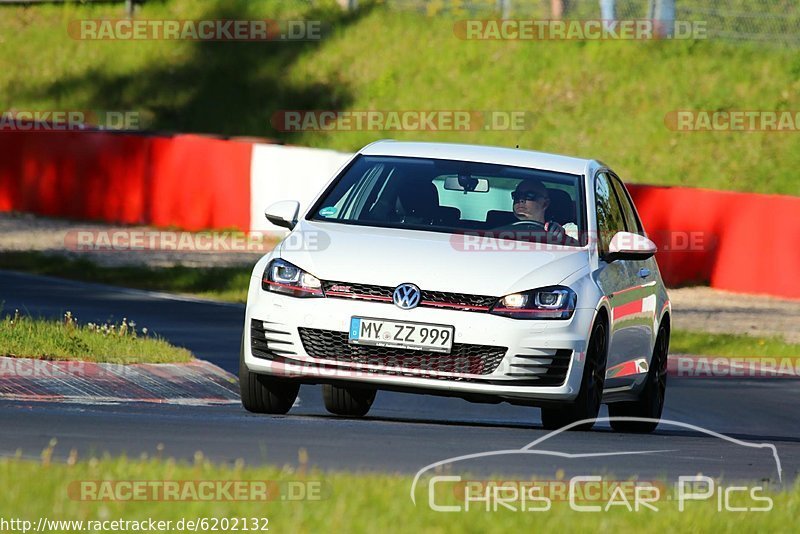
[0,0,800,195]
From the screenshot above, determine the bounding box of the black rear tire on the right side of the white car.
[608,324,669,434]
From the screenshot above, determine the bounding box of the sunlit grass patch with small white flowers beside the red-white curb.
[0,311,193,364]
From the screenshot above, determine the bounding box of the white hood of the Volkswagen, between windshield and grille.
[279,220,589,296]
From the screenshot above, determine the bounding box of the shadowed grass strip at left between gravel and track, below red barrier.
[0,251,252,302]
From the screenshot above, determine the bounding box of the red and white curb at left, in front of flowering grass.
[0,357,240,405]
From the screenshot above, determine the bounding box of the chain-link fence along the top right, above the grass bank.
[381,0,800,46]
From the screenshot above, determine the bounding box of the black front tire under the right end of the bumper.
[542,320,608,430]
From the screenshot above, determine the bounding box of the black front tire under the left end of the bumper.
[239,338,300,415]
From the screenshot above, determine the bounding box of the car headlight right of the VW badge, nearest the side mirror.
[491,286,578,319]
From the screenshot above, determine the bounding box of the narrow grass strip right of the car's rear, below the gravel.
[669,330,800,358]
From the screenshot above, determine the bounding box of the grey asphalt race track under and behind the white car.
[0,271,800,484]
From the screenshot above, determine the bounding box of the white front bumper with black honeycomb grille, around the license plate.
[244,278,594,405]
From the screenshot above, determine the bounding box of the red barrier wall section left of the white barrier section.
[0,132,252,231]
